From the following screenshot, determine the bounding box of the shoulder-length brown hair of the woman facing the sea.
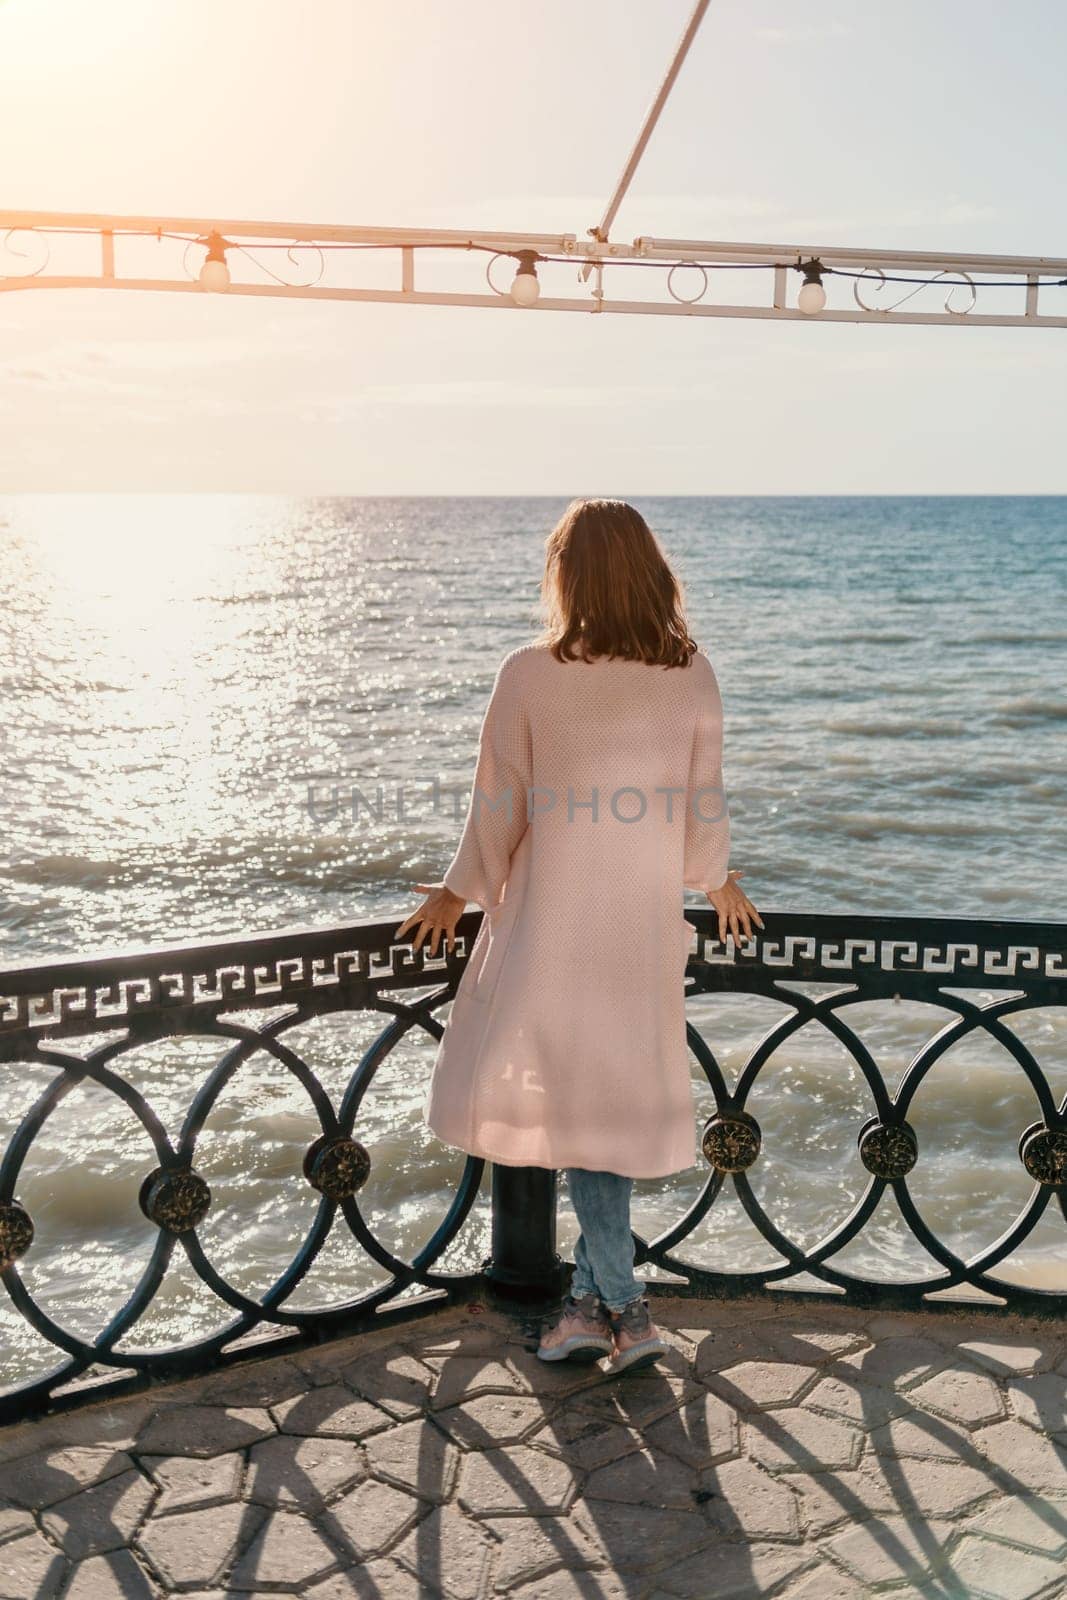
[539,499,697,667]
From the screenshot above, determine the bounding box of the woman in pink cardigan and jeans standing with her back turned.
[397,499,763,1371]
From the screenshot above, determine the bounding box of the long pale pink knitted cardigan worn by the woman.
[424,643,729,1178]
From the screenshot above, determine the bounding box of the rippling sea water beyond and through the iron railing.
[0,496,1067,1381]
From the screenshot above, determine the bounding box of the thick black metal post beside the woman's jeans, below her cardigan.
[482,1162,563,1298]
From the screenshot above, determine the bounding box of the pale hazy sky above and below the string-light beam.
[0,0,1067,496]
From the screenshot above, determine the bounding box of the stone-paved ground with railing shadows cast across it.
[0,1299,1067,1600]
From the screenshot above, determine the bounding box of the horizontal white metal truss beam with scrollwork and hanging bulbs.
[0,211,1067,328]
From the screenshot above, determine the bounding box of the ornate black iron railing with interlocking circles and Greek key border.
[0,907,1067,1421]
